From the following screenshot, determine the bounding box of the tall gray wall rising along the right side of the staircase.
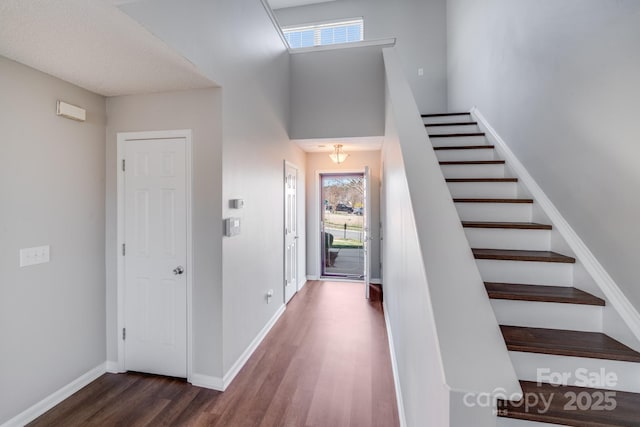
[448,0,640,309]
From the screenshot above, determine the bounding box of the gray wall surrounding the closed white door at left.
[106,88,222,377]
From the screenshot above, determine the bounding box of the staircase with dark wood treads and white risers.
[422,113,640,427]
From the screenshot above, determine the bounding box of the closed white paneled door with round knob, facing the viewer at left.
[123,138,190,378]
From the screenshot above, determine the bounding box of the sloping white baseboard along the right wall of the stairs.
[470,107,640,340]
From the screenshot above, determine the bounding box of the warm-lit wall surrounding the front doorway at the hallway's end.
[306,151,381,279]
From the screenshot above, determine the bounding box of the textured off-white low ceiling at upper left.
[0,0,215,96]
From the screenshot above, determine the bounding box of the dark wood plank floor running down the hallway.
[30,281,399,427]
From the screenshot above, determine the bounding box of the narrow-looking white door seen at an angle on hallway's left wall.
[284,162,298,304]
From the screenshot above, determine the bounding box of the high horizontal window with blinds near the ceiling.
[282,18,364,49]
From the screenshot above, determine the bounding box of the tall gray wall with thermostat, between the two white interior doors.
[122,0,305,373]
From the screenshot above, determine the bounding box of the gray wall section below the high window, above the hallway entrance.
[289,46,384,139]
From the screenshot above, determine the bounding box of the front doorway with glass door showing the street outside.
[320,173,367,280]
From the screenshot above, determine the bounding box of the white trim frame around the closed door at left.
[115,129,193,382]
